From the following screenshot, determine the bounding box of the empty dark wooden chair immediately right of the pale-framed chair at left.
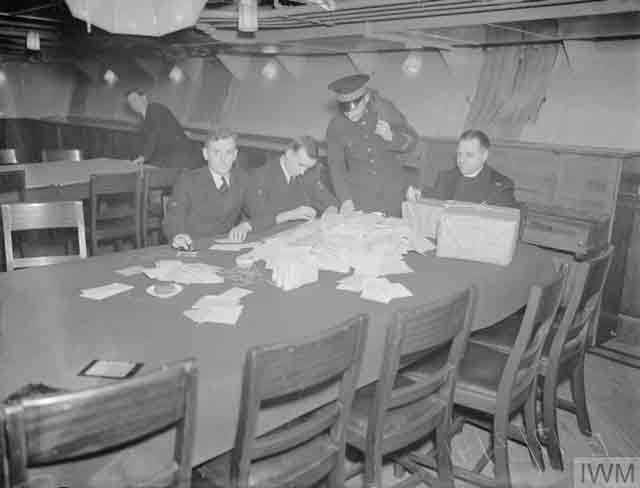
[89,172,142,256]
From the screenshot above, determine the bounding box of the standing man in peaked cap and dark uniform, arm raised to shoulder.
[327,74,418,216]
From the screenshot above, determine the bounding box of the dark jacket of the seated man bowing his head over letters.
[245,156,338,231]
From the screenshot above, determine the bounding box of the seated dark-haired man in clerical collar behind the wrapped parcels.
[406,130,519,208]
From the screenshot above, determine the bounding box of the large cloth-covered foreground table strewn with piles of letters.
[0,236,553,480]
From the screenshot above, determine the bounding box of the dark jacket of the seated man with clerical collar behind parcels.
[422,164,519,207]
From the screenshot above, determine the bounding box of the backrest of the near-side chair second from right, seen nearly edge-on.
[497,272,566,409]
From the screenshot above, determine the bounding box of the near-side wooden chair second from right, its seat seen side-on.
[405,273,565,488]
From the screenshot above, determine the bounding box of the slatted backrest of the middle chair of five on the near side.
[367,286,476,452]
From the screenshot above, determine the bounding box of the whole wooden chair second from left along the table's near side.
[200,315,368,488]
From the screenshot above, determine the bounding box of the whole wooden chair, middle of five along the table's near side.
[347,287,476,487]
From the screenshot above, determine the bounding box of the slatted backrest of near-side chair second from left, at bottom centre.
[231,315,369,486]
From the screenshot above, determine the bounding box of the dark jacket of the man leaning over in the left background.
[140,103,204,169]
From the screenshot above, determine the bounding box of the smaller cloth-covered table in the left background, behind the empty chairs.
[0,158,146,202]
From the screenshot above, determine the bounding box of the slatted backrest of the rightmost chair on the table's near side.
[549,246,614,357]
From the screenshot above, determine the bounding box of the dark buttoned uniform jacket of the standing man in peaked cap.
[327,91,418,216]
